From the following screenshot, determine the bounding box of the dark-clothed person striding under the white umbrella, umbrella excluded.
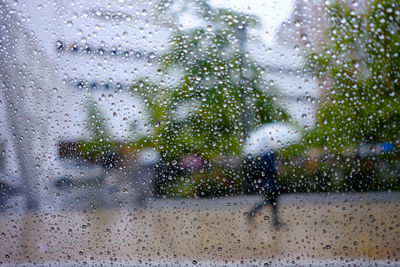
[245,151,281,227]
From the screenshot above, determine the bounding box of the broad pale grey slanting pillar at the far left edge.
[0,1,59,211]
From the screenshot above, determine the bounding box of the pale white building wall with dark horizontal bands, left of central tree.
[8,0,169,141]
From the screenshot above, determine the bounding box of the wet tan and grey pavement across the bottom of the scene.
[0,193,400,266]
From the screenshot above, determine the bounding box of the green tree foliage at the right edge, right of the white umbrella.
[306,0,400,152]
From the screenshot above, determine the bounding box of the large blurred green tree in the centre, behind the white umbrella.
[132,1,286,160]
